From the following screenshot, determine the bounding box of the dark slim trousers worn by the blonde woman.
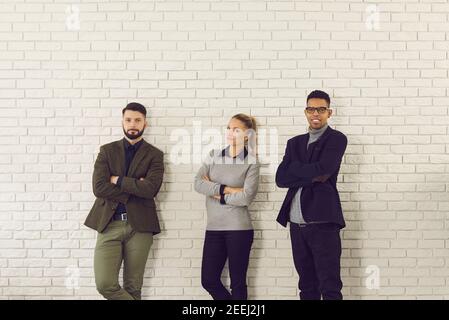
[201,230,254,300]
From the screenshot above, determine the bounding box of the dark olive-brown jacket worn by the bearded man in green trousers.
[84,140,164,234]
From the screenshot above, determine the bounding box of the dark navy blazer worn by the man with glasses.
[276,127,348,228]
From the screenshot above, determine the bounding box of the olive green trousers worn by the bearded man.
[94,221,153,300]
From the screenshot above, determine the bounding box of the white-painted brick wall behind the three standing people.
[0,0,449,299]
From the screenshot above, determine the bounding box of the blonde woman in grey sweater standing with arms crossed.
[195,114,259,300]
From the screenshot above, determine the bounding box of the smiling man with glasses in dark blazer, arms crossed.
[276,90,347,300]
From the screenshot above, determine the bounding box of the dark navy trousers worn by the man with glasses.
[290,223,343,300]
